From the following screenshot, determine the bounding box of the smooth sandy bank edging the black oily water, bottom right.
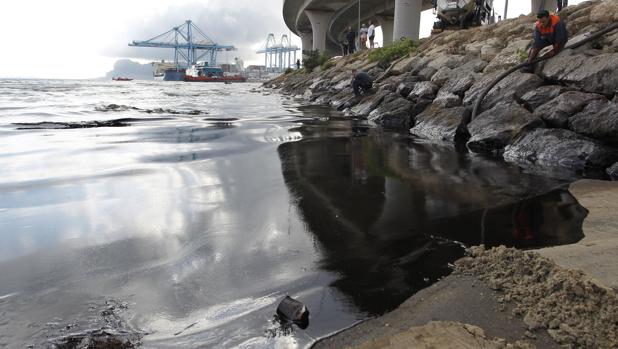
[314,180,618,349]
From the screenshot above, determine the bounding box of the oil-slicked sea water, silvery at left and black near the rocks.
[0,80,586,348]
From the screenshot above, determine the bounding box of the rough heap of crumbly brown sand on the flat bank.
[455,246,618,348]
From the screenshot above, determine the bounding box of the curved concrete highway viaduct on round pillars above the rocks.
[283,0,556,55]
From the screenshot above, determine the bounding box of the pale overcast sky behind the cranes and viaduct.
[0,0,583,78]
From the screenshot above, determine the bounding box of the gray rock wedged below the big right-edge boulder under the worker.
[534,91,605,128]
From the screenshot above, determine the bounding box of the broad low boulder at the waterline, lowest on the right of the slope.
[504,128,618,171]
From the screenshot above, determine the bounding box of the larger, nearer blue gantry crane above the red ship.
[129,20,236,68]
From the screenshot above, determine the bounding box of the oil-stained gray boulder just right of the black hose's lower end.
[467,102,544,153]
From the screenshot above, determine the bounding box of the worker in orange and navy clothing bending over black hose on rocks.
[524,10,569,72]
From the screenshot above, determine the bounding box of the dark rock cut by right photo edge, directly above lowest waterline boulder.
[569,99,618,144]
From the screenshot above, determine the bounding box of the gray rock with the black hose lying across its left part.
[464,72,543,111]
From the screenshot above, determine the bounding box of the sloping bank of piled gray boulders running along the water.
[265,0,618,180]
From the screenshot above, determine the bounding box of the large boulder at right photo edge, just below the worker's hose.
[541,50,618,95]
